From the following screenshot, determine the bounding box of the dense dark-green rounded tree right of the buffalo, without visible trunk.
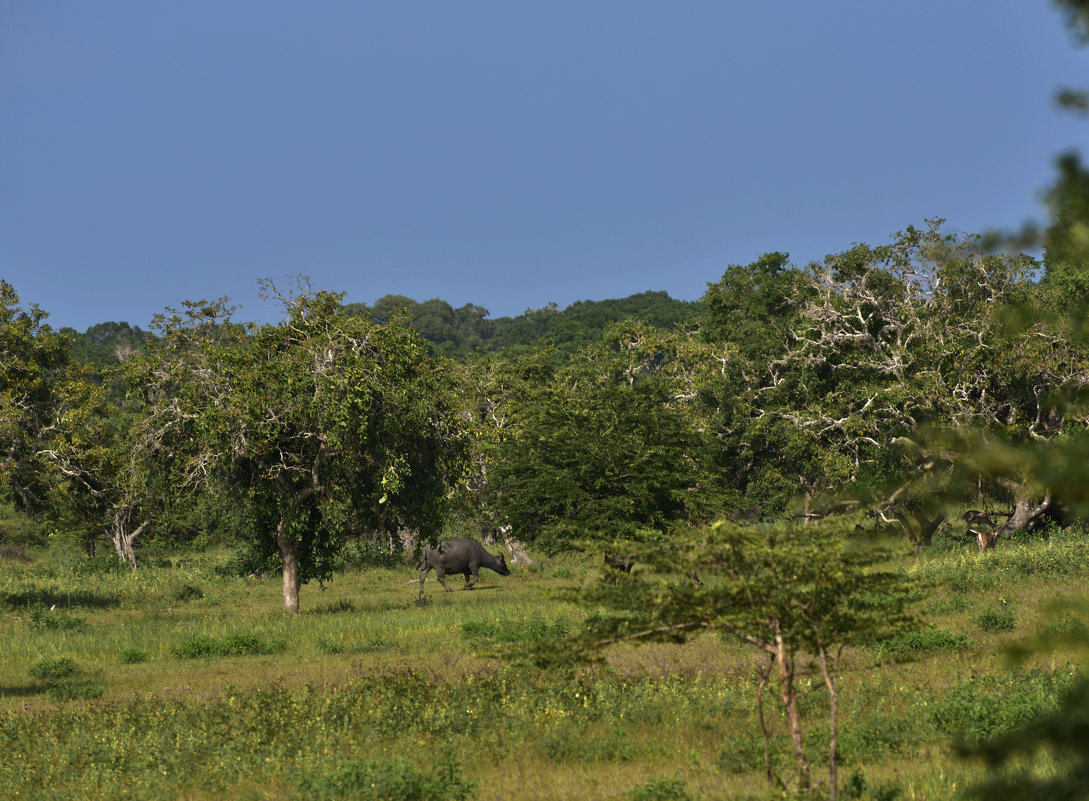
[492,323,720,550]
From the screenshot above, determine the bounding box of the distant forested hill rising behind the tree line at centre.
[345,292,702,358]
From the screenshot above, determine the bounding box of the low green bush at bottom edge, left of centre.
[298,756,476,801]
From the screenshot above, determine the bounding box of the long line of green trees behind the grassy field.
[0,213,1089,594]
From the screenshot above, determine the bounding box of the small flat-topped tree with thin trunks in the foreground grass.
[518,518,914,801]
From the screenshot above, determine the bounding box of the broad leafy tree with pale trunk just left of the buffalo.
[126,282,461,613]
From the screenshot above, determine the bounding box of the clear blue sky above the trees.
[0,0,1089,331]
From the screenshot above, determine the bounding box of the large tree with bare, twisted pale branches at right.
[776,220,1089,546]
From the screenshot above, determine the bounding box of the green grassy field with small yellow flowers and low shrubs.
[0,532,1089,801]
